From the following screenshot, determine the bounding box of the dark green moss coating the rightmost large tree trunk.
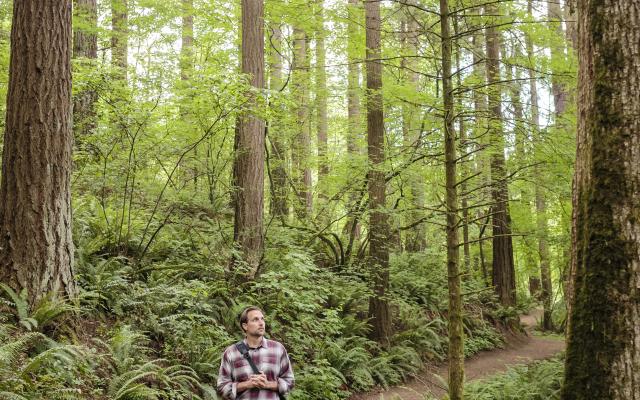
[563,1,635,400]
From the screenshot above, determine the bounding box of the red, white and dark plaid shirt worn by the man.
[217,338,293,400]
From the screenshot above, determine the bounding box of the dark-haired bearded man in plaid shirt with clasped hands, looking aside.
[217,307,293,400]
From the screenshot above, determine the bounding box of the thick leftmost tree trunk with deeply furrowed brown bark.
[0,0,76,305]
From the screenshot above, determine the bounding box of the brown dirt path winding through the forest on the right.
[349,309,565,400]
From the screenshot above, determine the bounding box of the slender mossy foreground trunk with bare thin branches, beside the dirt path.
[440,0,464,400]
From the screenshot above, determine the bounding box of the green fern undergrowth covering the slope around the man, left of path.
[0,223,501,400]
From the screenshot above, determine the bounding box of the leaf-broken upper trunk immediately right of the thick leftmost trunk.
[73,0,98,142]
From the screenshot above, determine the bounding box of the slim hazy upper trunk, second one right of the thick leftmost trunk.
[111,0,129,80]
